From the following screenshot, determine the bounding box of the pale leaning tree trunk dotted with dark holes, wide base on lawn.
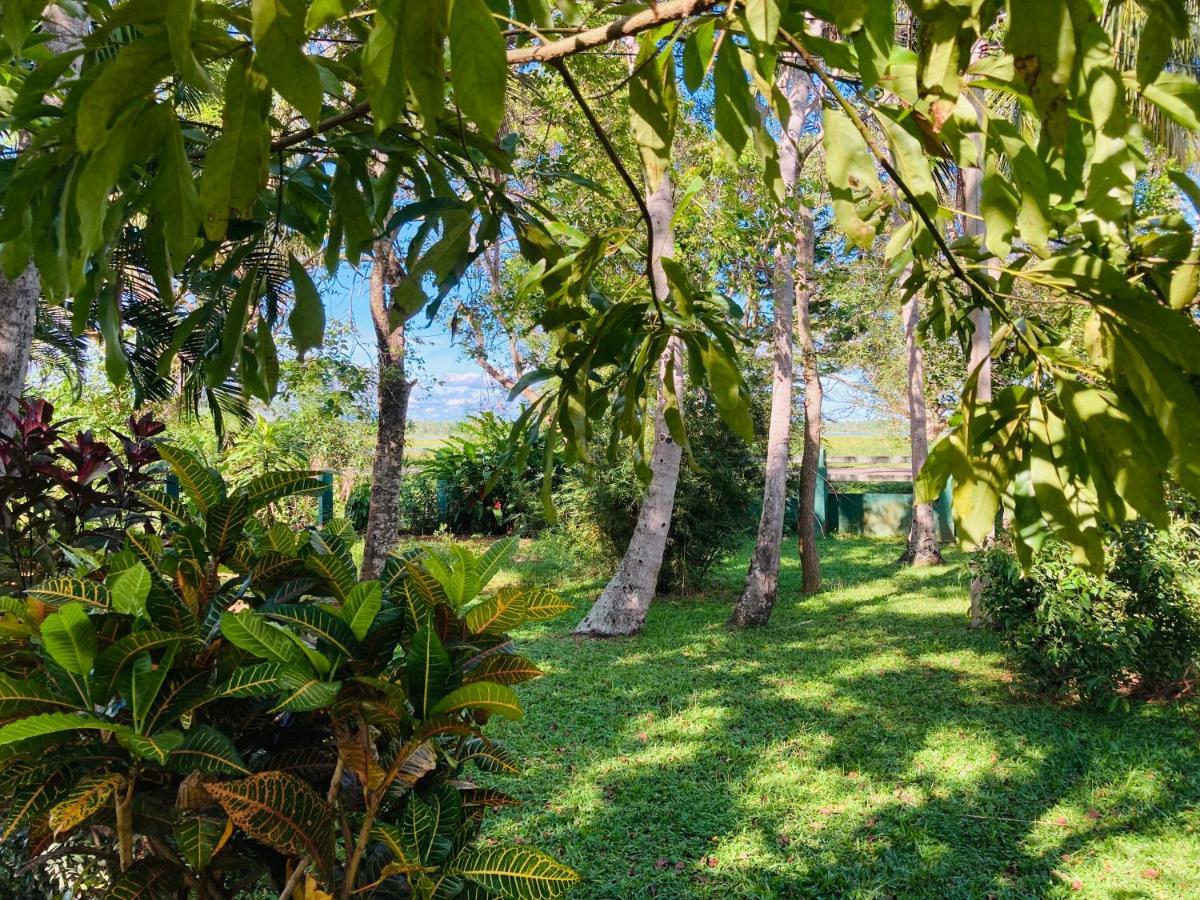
[575,175,684,637]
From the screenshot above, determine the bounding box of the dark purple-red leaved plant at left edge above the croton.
[0,400,163,590]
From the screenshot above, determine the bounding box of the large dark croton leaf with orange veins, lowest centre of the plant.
[205,772,334,876]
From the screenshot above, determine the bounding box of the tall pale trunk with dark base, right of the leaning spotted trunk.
[730,70,810,628]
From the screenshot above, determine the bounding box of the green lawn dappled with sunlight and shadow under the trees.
[472,539,1200,900]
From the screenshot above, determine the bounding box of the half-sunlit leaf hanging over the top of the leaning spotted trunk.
[629,31,678,193]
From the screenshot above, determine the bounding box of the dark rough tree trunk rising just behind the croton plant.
[362,240,415,580]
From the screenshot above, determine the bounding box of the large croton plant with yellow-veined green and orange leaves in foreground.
[0,443,577,900]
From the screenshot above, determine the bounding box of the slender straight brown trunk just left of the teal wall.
[796,209,823,594]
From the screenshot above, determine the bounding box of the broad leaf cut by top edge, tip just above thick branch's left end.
[252,0,323,125]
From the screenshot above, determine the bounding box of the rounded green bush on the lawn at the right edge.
[974,523,1200,706]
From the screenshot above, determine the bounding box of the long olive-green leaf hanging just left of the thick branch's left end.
[199,54,271,241]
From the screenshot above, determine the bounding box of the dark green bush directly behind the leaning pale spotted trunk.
[556,391,763,593]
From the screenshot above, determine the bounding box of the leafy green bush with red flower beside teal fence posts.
[420,413,545,534]
